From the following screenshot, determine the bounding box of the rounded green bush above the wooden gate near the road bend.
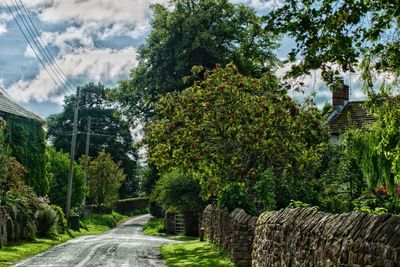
[152,169,203,217]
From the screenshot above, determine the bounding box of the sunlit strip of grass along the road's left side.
[0,212,128,267]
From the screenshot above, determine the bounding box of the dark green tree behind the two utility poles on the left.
[47,83,137,197]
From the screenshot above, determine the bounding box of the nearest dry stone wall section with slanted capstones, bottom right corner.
[252,208,400,267]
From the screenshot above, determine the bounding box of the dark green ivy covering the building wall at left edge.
[0,113,49,196]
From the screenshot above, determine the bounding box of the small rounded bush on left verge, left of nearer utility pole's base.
[35,204,57,237]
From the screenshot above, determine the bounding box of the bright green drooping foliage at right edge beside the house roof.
[345,87,400,212]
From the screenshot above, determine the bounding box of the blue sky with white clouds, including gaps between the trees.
[0,0,362,117]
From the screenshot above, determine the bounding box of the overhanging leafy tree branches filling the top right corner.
[268,0,400,89]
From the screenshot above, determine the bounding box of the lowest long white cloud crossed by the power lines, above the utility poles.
[7,47,136,103]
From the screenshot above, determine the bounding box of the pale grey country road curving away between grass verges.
[15,215,177,267]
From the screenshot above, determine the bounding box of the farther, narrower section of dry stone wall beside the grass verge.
[202,205,257,266]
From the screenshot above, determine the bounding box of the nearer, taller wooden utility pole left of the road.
[66,87,79,219]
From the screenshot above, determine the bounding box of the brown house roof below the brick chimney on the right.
[327,101,375,134]
